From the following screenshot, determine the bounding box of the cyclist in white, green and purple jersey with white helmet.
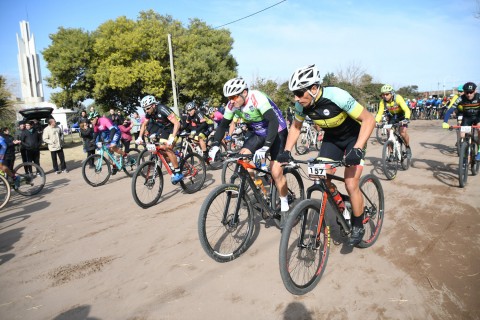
[209,78,289,221]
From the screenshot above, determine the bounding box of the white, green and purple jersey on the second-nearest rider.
[223,90,287,137]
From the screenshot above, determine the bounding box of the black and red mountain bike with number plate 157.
[279,158,385,295]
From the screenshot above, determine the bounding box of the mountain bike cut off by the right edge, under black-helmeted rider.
[450,125,480,188]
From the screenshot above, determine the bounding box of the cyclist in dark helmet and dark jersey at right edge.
[442,82,480,161]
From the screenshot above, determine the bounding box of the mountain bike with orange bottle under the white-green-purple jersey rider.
[198,154,305,262]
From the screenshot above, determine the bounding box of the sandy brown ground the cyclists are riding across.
[0,121,480,320]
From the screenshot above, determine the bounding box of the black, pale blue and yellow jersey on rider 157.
[295,87,364,140]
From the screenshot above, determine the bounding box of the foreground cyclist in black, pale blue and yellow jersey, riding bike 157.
[278,65,375,246]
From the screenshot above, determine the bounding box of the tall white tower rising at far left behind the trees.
[17,21,44,104]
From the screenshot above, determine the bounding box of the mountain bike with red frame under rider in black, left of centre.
[131,143,207,208]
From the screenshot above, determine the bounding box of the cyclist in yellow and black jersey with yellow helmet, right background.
[375,84,412,159]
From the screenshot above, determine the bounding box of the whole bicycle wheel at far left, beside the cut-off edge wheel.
[13,162,46,196]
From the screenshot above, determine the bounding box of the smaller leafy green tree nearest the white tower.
[42,27,94,108]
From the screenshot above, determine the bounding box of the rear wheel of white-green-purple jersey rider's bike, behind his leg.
[272,168,305,228]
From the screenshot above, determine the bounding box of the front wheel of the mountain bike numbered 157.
[279,199,330,295]
